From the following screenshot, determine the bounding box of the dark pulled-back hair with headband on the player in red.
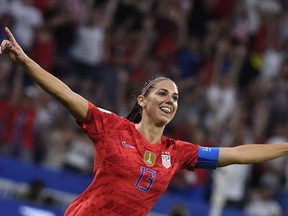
[126,76,169,123]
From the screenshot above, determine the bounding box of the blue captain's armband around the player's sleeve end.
[195,146,219,169]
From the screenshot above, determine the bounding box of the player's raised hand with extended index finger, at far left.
[0,27,28,64]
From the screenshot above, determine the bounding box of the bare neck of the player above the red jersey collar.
[135,122,164,144]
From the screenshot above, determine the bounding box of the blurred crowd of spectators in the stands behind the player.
[0,0,288,216]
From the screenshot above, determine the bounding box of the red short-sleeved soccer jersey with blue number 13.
[65,103,199,216]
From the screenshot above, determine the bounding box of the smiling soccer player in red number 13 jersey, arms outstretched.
[1,28,288,216]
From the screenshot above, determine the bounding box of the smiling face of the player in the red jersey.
[138,79,179,127]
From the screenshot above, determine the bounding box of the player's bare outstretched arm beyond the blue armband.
[218,143,288,167]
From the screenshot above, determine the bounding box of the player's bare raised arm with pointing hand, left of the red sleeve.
[0,27,88,122]
